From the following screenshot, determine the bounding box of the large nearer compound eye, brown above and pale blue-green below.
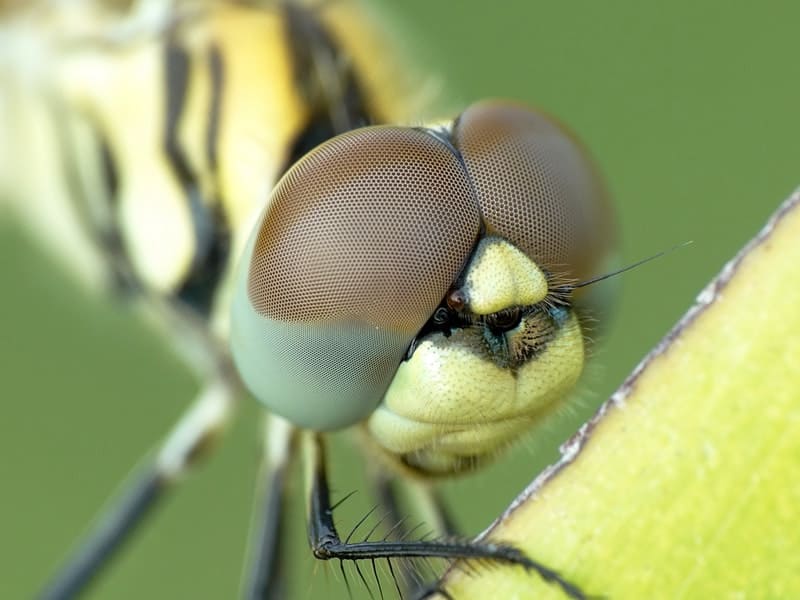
[232,127,480,429]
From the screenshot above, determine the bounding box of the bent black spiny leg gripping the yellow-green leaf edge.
[303,432,587,600]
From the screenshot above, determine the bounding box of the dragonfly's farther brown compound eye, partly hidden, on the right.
[453,101,614,288]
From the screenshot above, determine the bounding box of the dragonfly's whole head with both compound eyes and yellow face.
[231,101,611,474]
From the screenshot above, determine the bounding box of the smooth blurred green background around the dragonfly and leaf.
[0,0,800,599]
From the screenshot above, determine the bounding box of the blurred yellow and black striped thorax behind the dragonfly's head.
[6,1,416,324]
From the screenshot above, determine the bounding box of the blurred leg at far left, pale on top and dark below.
[39,377,238,600]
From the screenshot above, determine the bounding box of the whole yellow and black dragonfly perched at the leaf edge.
[3,0,613,599]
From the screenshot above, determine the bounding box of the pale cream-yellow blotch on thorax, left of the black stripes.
[59,40,195,294]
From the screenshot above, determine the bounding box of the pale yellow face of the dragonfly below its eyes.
[366,237,584,475]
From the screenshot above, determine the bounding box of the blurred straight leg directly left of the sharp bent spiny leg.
[244,415,297,600]
